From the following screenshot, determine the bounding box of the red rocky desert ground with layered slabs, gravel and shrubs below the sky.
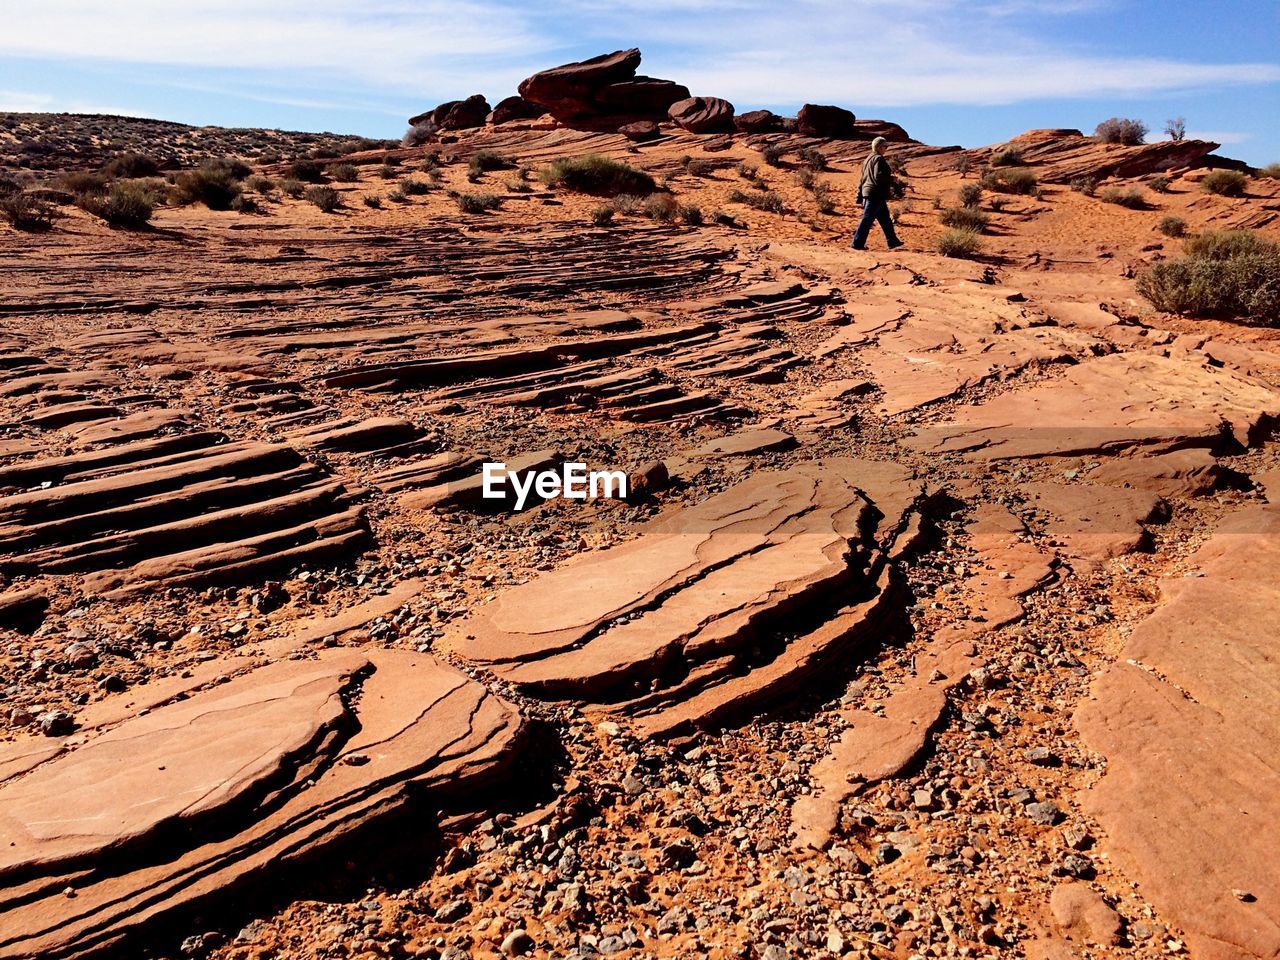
[0,41,1280,960]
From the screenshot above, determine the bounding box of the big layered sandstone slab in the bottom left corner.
[0,650,522,959]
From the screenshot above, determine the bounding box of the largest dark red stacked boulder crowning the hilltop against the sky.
[520,47,689,131]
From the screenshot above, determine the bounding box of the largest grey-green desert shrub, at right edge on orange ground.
[1138,230,1280,325]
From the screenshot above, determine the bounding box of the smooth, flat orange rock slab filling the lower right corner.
[1076,506,1280,960]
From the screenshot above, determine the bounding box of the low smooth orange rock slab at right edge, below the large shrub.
[909,353,1280,460]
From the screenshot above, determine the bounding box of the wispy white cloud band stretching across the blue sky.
[0,0,1280,109]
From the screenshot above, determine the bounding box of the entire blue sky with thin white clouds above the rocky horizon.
[0,0,1280,164]
